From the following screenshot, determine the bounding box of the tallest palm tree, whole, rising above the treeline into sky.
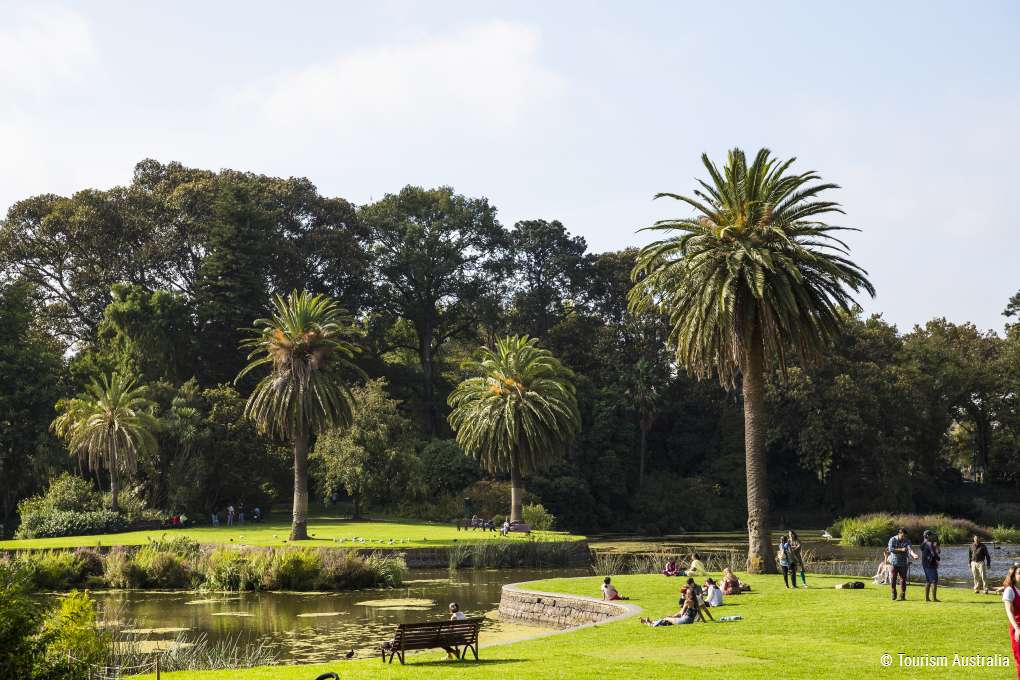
[630,149,875,571]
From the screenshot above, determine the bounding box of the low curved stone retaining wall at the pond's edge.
[500,583,632,628]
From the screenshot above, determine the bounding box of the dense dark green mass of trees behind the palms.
[0,160,1020,533]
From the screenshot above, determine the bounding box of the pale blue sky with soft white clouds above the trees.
[0,0,1020,332]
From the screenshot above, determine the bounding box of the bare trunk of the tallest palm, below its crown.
[742,330,775,574]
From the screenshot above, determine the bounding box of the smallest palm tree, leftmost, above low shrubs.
[50,372,159,512]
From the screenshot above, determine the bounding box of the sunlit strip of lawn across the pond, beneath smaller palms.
[0,517,581,550]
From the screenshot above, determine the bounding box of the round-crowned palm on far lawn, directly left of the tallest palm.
[449,335,580,521]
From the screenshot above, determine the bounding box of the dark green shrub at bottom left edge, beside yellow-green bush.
[0,558,42,678]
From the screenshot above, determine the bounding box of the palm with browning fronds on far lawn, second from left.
[235,291,362,540]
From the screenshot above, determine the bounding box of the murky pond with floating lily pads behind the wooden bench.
[94,569,591,663]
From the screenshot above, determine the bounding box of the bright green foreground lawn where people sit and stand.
[129,575,1016,680]
